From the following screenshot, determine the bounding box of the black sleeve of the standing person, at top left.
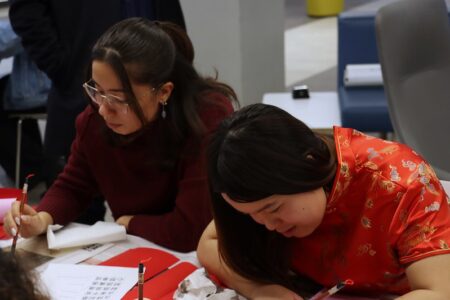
[9,0,70,84]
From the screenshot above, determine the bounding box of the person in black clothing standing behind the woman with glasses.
[9,0,185,223]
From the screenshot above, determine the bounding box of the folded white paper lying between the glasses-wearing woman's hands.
[47,222,127,249]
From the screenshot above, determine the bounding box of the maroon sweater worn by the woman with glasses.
[37,94,233,252]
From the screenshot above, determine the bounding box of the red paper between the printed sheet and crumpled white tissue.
[100,247,197,300]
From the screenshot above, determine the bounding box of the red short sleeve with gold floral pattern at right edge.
[397,160,450,263]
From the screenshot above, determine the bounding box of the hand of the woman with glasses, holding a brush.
[3,201,53,238]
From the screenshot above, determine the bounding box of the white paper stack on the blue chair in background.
[344,64,383,86]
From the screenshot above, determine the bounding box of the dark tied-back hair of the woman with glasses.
[89,18,237,169]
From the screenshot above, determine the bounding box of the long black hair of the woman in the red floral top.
[208,104,336,292]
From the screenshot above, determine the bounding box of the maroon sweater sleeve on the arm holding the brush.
[37,107,99,225]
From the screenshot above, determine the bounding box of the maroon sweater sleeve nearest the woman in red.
[128,96,233,252]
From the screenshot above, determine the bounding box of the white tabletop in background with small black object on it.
[262,92,342,131]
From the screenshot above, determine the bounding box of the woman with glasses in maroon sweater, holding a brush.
[4,18,236,251]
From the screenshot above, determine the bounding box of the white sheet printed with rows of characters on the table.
[40,264,138,300]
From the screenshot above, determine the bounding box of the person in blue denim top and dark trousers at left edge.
[0,19,51,187]
